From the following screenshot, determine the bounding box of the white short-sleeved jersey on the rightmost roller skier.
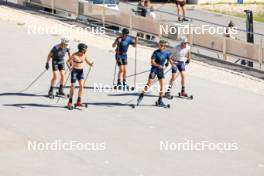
[171,44,191,62]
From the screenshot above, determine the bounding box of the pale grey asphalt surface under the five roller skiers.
[0,16,264,176]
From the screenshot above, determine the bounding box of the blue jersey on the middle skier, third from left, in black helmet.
[116,36,134,59]
